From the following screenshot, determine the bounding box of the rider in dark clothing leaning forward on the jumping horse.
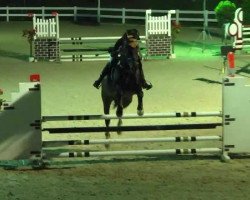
[93,29,152,90]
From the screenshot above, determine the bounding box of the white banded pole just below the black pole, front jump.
[43,135,222,147]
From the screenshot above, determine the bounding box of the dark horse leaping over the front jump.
[101,42,144,139]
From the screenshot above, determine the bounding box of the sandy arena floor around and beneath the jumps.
[0,22,250,200]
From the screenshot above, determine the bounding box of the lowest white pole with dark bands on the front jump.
[57,148,222,158]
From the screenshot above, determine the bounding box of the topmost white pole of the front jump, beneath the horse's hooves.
[42,111,222,122]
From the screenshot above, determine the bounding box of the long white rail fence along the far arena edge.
[0,6,217,26]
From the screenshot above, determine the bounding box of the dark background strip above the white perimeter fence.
[0,0,243,10]
